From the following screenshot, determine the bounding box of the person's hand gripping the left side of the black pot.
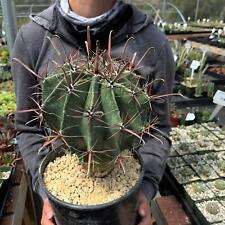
[41,198,54,225]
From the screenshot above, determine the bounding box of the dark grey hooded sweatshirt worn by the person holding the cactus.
[12,0,174,200]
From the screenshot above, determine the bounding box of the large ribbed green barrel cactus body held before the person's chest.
[42,55,150,175]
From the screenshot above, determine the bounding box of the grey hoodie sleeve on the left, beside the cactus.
[12,26,48,198]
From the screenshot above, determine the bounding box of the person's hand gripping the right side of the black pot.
[137,192,153,225]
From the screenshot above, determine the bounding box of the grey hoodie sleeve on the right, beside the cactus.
[139,41,175,200]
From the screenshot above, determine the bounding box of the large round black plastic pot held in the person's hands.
[39,150,144,225]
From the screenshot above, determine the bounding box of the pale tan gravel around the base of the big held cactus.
[44,151,140,205]
